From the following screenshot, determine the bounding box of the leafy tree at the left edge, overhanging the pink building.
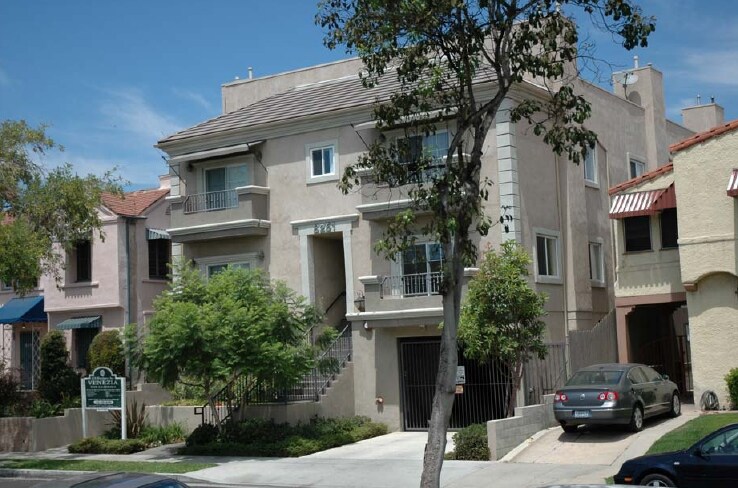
[0,120,121,295]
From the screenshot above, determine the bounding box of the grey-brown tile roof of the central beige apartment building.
[159,68,494,144]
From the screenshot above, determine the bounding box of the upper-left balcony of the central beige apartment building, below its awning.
[168,186,270,242]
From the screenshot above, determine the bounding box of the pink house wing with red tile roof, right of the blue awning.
[42,177,171,369]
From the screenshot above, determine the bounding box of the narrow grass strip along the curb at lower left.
[0,459,217,474]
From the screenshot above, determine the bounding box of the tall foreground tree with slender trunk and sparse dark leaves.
[316,0,654,486]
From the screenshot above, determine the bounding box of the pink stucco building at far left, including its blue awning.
[0,176,171,389]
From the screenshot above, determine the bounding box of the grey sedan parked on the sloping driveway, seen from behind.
[554,364,681,432]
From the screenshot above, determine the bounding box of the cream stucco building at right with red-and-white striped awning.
[610,116,738,406]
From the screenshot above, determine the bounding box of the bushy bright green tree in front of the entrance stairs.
[140,264,320,420]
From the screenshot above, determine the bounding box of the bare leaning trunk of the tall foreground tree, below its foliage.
[420,238,464,488]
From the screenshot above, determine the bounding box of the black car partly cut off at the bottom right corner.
[615,424,738,488]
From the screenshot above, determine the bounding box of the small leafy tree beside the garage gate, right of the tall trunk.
[458,241,547,415]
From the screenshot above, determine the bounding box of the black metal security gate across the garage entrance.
[400,337,510,430]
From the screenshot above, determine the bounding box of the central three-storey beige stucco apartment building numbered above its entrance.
[157,59,693,429]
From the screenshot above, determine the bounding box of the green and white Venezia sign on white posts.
[82,366,127,439]
